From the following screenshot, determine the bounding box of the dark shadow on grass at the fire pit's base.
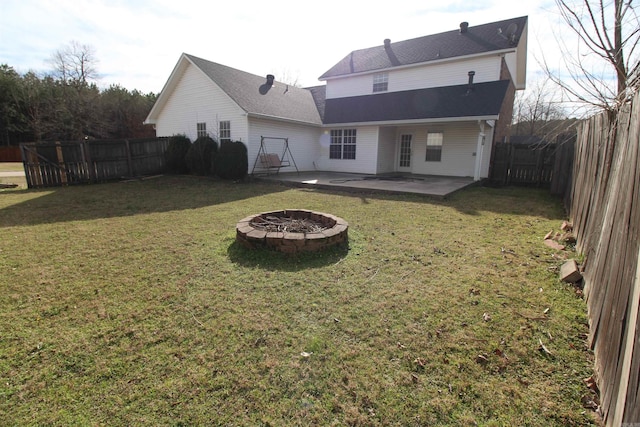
[227,241,349,272]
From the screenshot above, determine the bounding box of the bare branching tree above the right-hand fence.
[543,0,640,111]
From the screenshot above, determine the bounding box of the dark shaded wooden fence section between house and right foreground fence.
[489,137,575,196]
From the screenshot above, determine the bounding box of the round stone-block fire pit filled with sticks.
[236,209,349,254]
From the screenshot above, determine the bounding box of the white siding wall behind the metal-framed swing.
[247,117,322,173]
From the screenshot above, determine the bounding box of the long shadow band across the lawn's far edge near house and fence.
[0,176,565,229]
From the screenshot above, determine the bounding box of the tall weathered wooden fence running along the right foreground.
[570,93,640,426]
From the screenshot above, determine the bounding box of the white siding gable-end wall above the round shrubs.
[156,65,248,142]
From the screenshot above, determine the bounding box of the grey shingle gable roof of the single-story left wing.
[145,53,322,125]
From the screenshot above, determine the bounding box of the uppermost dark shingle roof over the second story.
[319,16,527,80]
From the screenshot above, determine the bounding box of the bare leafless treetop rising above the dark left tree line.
[50,41,98,85]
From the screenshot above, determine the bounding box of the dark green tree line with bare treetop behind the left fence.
[0,42,157,145]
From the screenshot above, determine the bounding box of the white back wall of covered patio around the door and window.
[396,122,490,177]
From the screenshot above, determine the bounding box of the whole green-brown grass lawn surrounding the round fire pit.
[0,177,595,426]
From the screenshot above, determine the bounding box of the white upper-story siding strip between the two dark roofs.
[327,55,500,99]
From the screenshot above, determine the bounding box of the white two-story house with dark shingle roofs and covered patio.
[145,17,527,180]
